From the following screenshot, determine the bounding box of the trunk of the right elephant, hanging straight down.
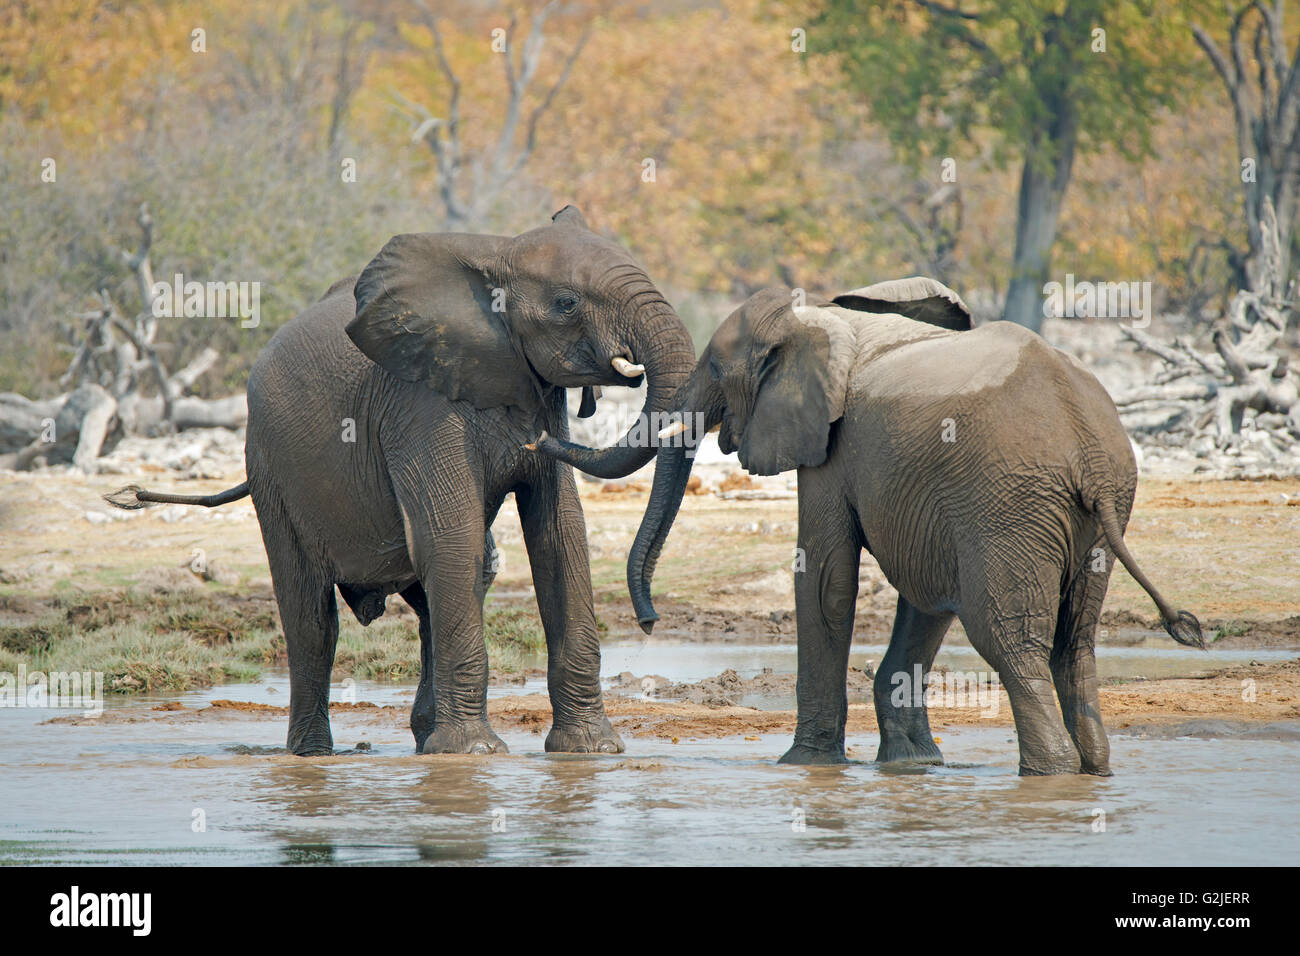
[628,375,722,633]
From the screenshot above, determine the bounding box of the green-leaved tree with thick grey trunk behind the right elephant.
[811,0,1195,329]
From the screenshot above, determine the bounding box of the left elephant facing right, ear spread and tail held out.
[107,206,696,754]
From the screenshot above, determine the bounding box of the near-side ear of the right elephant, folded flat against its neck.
[736,315,842,475]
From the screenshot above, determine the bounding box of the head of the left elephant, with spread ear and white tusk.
[347,206,696,477]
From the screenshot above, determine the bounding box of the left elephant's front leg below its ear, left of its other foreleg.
[397,481,508,753]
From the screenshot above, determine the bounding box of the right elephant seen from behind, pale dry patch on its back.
[542,276,1204,775]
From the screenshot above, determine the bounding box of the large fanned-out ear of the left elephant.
[347,233,541,408]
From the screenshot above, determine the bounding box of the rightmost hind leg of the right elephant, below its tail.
[1052,553,1114,777]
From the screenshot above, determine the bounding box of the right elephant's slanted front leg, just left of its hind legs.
[872,594,953,763]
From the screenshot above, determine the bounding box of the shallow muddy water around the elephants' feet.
[0,644,1300,865]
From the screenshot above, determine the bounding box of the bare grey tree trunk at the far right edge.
[1192,0,1300,295]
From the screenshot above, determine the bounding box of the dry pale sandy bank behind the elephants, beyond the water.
[0,467,1300,648]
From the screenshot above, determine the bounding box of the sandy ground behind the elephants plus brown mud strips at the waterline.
[0,470,1300,739]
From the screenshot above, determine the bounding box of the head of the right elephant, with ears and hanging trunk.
[616,277,971,633]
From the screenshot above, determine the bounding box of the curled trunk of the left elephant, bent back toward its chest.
[537,290,696,479]
